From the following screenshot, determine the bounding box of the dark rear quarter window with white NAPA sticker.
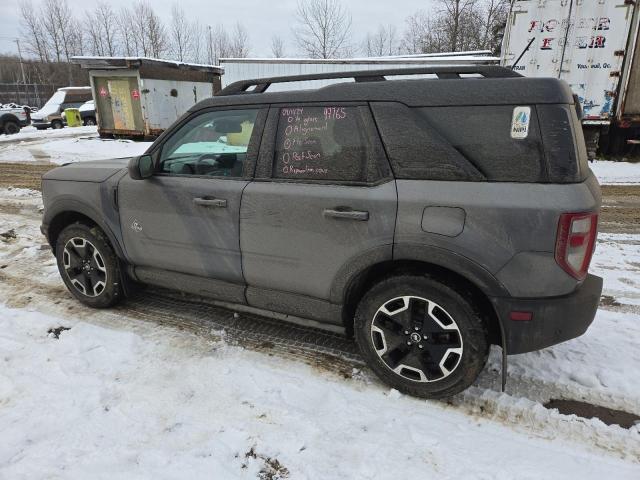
[372,103,547,182]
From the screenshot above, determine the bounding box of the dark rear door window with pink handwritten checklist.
[273,105,372,182]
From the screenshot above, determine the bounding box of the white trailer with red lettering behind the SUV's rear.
[501,0,640,156]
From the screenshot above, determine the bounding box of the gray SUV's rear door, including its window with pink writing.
[240,104,397,310]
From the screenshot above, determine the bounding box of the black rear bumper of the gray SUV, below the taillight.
[491,275,602,355]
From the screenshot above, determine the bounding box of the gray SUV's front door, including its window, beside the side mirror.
[119,108,266,284]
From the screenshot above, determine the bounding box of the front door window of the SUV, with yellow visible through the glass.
[158,109,258,178]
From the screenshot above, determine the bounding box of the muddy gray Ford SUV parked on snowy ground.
[42,66,602,398]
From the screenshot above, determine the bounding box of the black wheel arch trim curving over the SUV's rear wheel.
[341,249,506,345]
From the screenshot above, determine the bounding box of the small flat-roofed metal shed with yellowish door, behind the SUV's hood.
[73,57,224,137]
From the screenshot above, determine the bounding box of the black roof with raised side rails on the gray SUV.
[191,66,573,111]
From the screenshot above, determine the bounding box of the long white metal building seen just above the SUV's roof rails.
[220,50,500,91]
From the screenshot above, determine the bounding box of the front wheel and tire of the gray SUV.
[56,223,123,308]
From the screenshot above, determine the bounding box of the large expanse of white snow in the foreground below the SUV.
[0,307,640,479]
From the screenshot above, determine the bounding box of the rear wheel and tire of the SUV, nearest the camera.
[354,275,490,398]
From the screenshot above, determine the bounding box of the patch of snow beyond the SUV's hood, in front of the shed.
[0,127,151,164]
